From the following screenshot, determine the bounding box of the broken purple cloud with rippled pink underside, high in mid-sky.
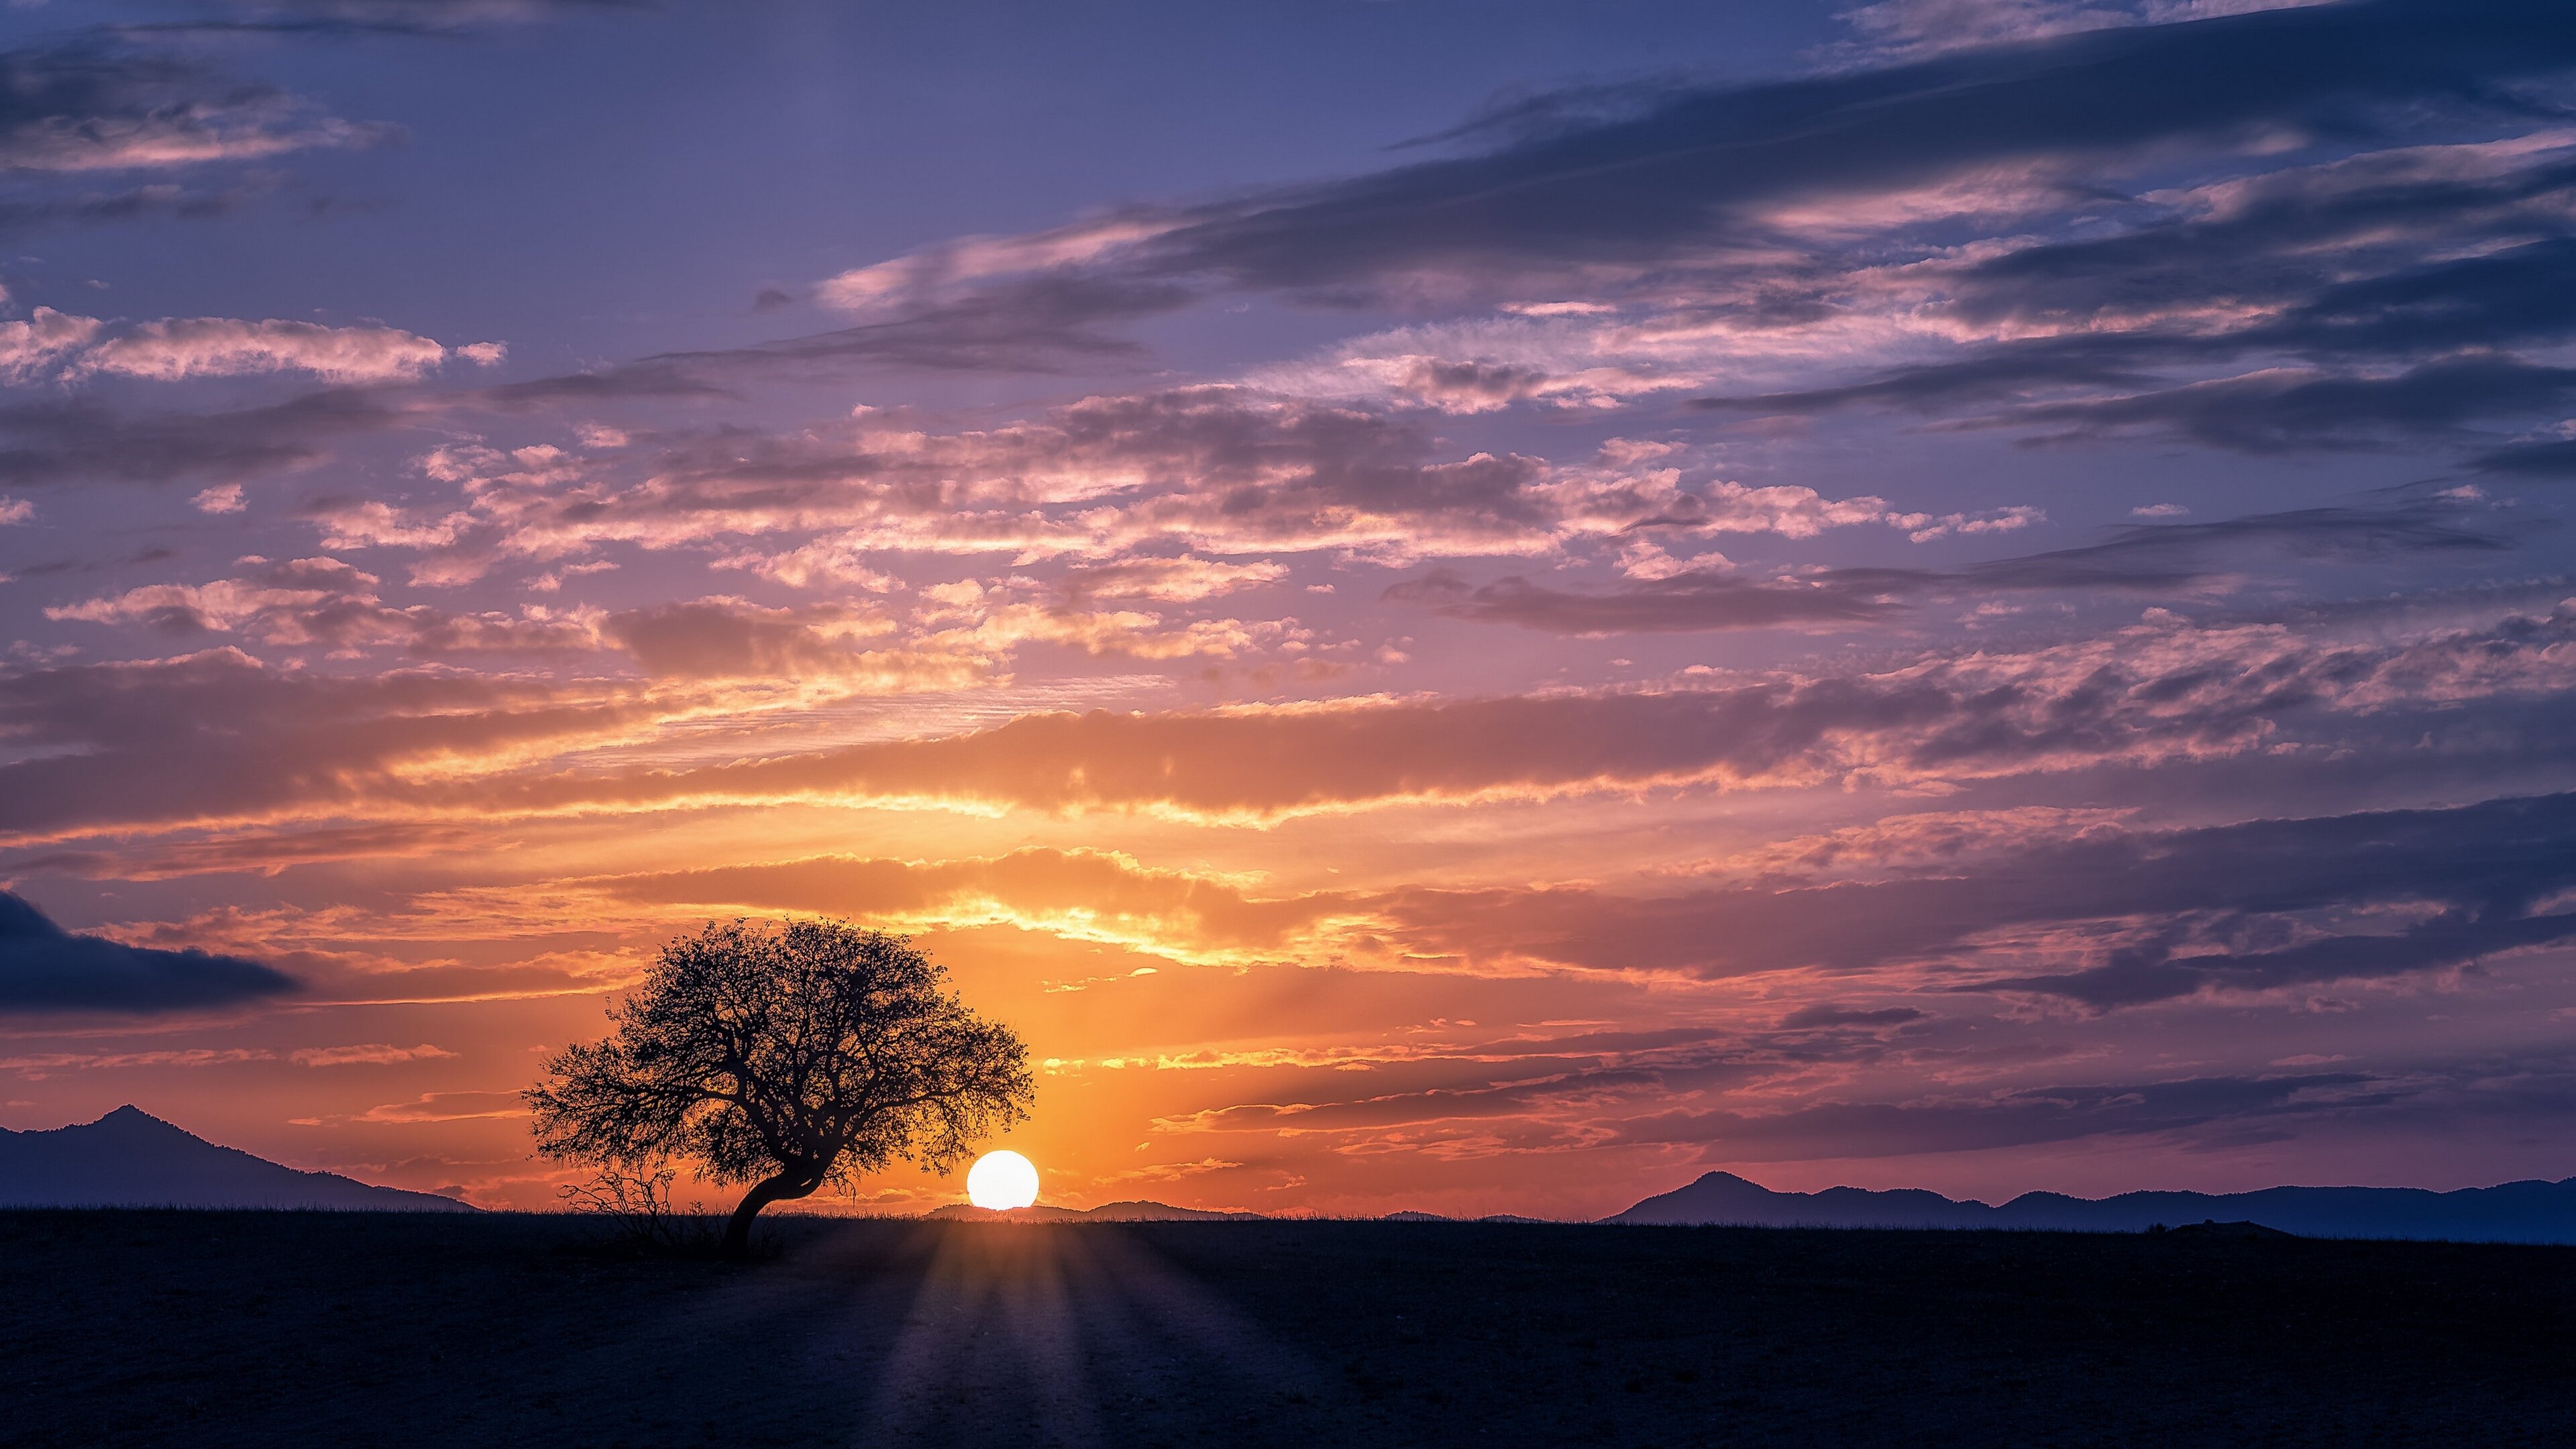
[309,384,1957,588]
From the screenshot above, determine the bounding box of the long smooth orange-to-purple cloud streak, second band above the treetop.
[412,600,2576,817]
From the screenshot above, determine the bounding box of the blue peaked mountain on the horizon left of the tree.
[0,1106,474,1212]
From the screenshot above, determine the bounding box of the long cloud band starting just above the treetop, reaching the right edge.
[546,778,2576,1005]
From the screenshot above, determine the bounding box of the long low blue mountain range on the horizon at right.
[1602,1173,2576,1243]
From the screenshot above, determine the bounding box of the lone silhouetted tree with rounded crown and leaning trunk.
[525,920,1036,1256]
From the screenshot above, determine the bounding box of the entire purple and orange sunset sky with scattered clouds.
[0,0,2576,1214]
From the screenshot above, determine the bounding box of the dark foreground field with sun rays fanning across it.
[0,1212,2576,1449]
